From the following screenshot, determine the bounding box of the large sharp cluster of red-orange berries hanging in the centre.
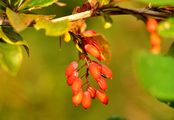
[65,30,112,109]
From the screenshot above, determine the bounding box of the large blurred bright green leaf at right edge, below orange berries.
[135,52,174,101]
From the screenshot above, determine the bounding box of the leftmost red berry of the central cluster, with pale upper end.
[65,61,78,78]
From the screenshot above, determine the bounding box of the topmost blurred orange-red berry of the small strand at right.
[146,18,158,33]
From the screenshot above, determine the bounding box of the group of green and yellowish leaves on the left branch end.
[0,0,70,75]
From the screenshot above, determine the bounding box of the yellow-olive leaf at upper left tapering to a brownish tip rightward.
[6,8,54,32]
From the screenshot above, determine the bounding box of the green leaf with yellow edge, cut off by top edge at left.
[19,0,58,10]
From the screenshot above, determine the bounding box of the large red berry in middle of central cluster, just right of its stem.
[89,62,101,80]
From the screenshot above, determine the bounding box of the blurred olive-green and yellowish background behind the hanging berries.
[0,0,174,120]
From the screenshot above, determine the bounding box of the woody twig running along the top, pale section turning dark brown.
[0,6,174,26]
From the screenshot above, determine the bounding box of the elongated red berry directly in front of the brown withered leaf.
[85,44,100,58]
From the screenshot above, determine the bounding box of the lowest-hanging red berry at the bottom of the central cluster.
[82,91,91,109]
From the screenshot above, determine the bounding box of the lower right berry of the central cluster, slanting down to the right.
[96,90,108,105]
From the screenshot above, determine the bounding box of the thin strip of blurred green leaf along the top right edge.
[136,0,174,5]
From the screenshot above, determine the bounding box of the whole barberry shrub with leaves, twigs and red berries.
[0,0,174,120]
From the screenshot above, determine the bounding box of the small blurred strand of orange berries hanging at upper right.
[146,18,161,54]
